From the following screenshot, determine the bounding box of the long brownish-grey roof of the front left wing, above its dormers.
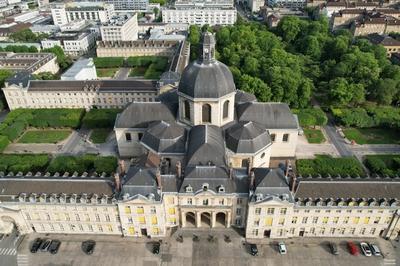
[0,177,114,196]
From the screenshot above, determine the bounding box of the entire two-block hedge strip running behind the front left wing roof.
[0,154,117,175]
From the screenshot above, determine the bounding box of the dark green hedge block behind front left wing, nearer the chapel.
[47,155,117,175]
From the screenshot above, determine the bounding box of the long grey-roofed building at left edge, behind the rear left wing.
[0,52,60,74]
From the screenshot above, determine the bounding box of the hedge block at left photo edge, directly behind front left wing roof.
[0,154,49,174]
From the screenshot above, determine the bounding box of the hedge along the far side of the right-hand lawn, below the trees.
[331,106,400,128]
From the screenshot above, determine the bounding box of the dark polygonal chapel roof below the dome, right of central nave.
[225,121,271,153]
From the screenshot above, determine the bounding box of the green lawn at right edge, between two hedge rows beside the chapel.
[343,128,400,145]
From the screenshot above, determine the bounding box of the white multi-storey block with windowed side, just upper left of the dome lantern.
[100,14,138,41]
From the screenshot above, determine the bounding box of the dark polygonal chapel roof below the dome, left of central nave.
[141,121,186,153]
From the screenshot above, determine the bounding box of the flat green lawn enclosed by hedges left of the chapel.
[18,129,71,143]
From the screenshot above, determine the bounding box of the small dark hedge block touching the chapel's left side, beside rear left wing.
[82,109,122,128]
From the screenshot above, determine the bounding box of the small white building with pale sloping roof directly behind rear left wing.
[61,58,97,80]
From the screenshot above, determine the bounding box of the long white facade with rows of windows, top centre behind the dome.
[162,8,237,26]
